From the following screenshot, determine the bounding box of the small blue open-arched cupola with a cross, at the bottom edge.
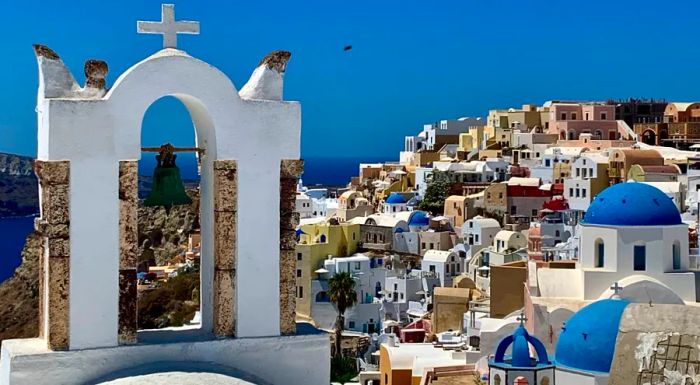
[491,325,551,368]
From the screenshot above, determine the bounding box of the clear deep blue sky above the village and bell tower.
[0,0,700,159]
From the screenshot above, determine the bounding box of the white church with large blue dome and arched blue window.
[537,182,696,304]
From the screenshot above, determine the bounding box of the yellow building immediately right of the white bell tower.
[295,223,360,320]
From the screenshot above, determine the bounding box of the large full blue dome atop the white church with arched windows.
[582,182,683,226]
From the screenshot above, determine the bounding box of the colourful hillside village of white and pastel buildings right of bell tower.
[295,99,700,385]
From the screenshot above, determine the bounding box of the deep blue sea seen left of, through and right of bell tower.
[0,154,386,282]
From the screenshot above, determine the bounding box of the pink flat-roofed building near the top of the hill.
[549,102,624,140]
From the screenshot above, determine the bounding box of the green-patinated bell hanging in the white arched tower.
[143,144,192,212]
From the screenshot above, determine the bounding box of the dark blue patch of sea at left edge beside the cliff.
[0,217,34,282]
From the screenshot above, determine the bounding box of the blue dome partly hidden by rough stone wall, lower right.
[555,299,630,373]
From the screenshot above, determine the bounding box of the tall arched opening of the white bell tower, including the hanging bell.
[137,96,201,330]
